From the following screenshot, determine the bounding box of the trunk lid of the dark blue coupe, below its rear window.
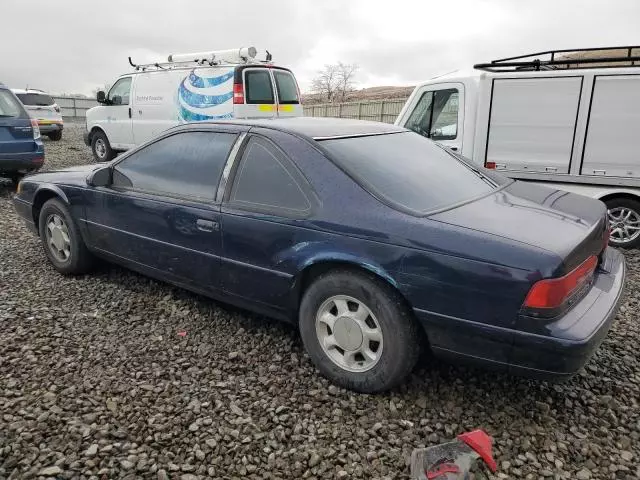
[430,182,608,276]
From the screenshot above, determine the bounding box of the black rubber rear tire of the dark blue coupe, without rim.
[299,270,424,393]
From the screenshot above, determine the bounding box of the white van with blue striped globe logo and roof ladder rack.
[84,47,303,162]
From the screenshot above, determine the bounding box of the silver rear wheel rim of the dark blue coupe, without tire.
[316,295,384,373]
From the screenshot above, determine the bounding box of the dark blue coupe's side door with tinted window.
[88,127,238,291]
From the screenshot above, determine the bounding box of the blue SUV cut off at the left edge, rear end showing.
[0,83,44,183]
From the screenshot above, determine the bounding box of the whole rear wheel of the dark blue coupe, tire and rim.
[299,270,421,393]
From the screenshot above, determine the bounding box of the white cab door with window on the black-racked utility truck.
[399,83,464,152]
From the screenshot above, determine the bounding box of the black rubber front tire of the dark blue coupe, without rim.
[38,198,94,275]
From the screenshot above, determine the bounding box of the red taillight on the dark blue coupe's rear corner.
[524,256,598,308]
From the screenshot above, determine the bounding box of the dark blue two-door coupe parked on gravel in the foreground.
[14,118,625,392]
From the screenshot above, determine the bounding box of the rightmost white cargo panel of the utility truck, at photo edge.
[580,74,640,178]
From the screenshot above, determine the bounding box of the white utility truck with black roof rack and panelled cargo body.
[395,47,640,247]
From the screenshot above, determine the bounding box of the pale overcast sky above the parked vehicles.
[0,0,640,94]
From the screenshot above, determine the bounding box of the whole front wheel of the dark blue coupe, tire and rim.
[39,198,93,275]
